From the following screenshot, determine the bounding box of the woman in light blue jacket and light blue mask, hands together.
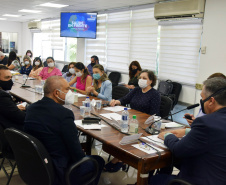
[87,64,112,101]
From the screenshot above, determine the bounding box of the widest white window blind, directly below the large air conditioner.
[158,20,202,85]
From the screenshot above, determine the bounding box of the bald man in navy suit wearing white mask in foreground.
[24,76,104,185]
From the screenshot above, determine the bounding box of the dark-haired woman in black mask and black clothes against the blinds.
[125,61,142,89]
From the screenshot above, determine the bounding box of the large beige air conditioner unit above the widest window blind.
[154,0,205,20]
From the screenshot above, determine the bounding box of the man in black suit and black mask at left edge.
[0,65,26,130]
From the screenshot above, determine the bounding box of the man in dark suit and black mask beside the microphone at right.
[150,78,226,185]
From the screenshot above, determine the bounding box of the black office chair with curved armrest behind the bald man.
[5,128,99,185]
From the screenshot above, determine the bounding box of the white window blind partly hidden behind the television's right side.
[85,14,107,67]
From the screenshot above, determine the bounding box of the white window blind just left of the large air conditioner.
[129,8,158,71]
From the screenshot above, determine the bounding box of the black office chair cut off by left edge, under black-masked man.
[0,124,16,185]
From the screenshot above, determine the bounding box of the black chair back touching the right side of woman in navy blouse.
[160,95,173,118]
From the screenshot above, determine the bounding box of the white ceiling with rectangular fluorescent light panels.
[0,0,166,22]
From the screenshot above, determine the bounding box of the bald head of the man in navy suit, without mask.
[44,76,68,96]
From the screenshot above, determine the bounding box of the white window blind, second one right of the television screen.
[107,11,131,72]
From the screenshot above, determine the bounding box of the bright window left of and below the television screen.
[33,19,77,62]
